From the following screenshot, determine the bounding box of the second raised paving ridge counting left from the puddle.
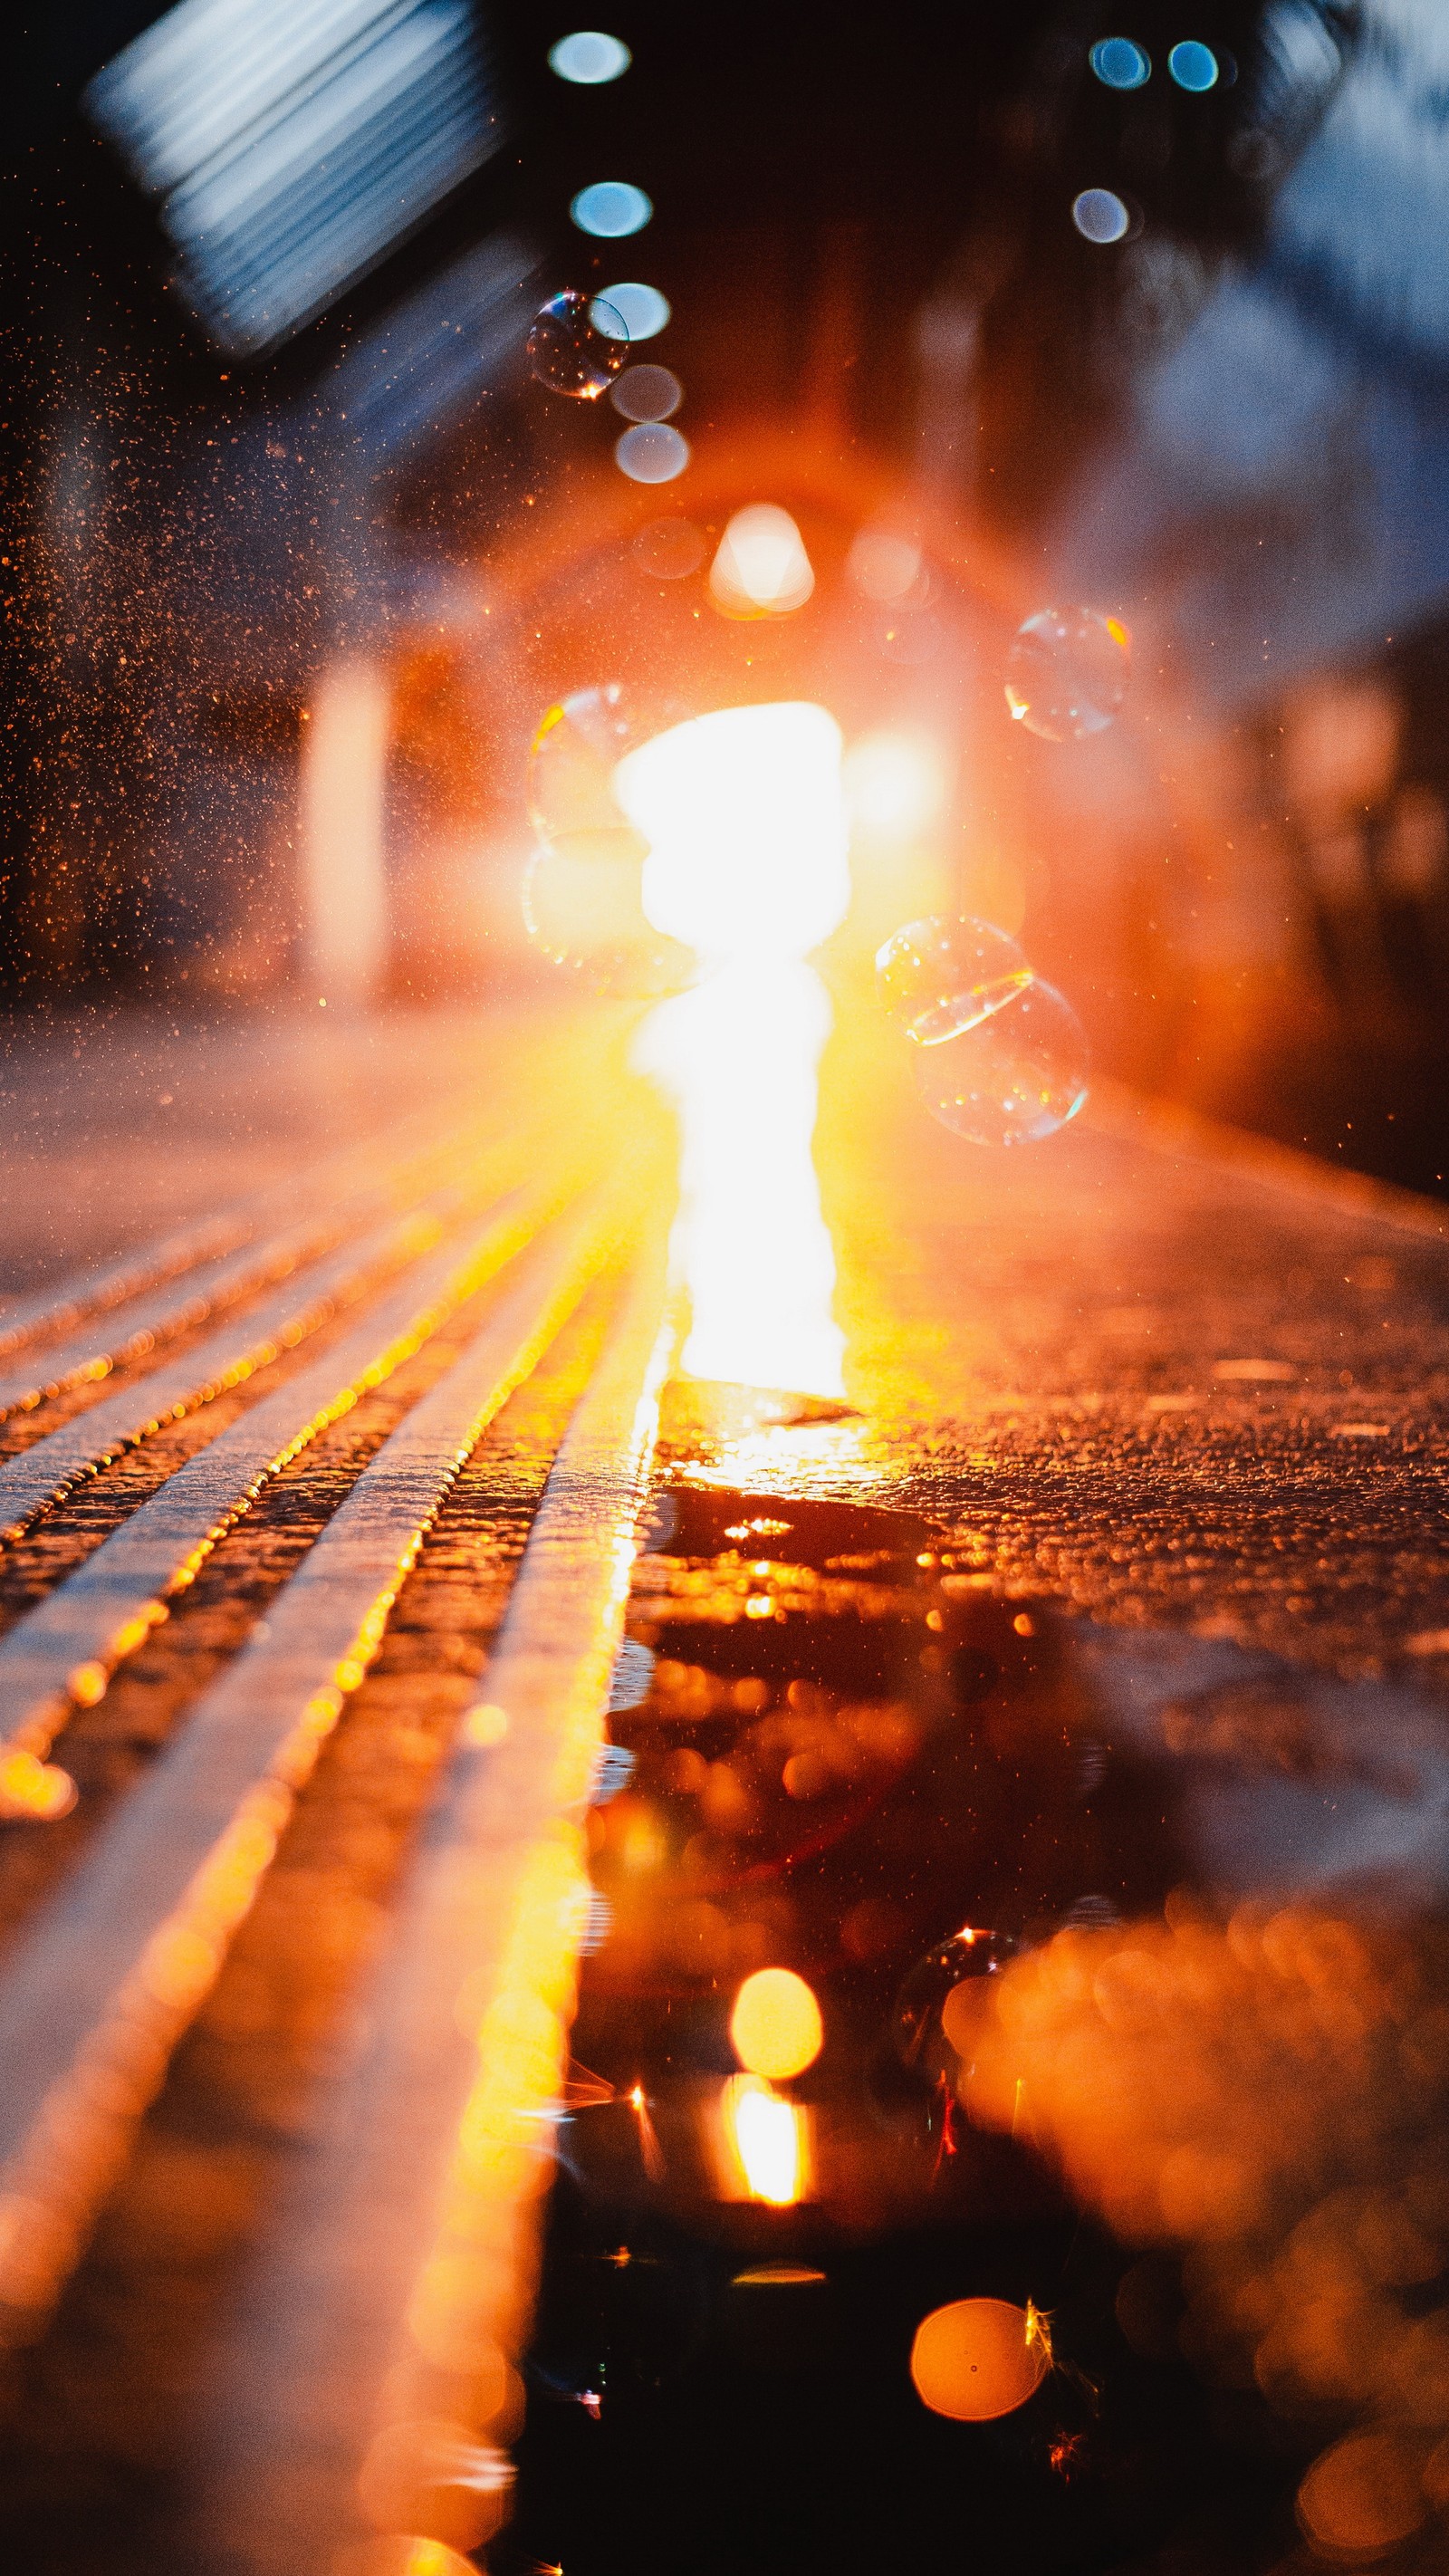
[0,1203,640,2341]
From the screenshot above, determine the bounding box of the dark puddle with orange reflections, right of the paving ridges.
[492,1486,1449,2576]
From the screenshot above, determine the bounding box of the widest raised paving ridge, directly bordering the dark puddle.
[193,1216,675,2576]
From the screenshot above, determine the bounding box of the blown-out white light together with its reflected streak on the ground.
[615,703,849,1396]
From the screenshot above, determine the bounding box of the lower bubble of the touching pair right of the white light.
[916,976,1089,1147]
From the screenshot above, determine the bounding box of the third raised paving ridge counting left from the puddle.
[0,1190,576,1821]
